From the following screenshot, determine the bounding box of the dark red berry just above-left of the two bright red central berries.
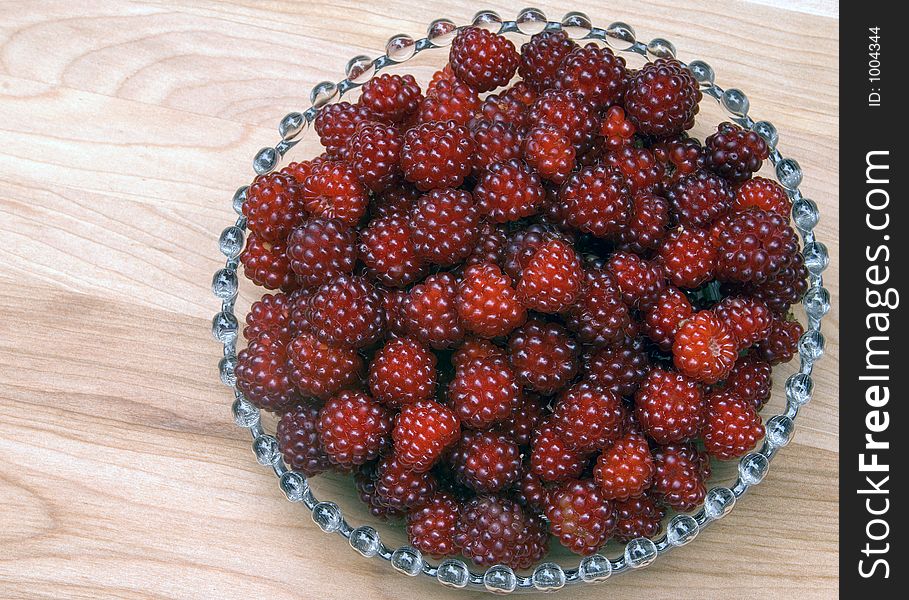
[410,188,480,266]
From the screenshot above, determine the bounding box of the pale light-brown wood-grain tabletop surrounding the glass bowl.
[0,0,839,599]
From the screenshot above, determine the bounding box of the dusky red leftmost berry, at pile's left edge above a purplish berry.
[234,331,299,412]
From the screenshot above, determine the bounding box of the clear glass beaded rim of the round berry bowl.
[212,8,830,593]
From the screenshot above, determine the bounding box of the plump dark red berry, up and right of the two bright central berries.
[559,166,632,237]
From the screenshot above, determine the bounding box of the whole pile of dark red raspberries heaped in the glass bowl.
[236,27,807,569]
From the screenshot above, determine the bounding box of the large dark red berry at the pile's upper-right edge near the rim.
[625,58,702,137]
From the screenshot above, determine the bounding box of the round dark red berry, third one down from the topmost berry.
[401,121,476,192]
